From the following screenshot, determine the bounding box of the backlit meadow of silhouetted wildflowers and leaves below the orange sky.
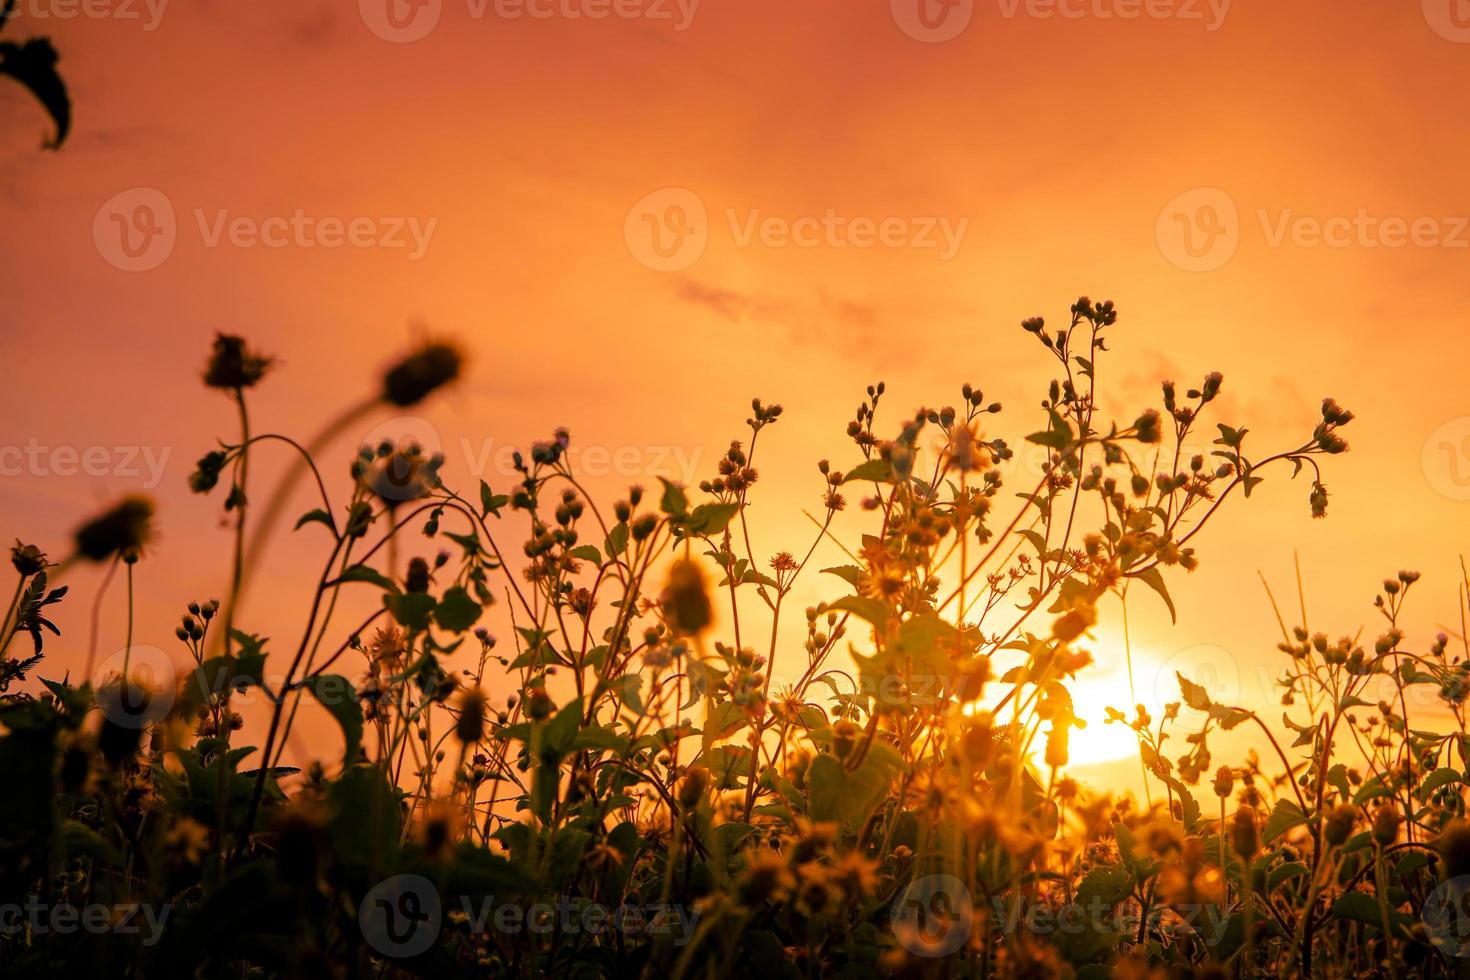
[0,298,1470,980]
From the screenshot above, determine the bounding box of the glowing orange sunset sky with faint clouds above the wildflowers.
[0,0,1470,793]
